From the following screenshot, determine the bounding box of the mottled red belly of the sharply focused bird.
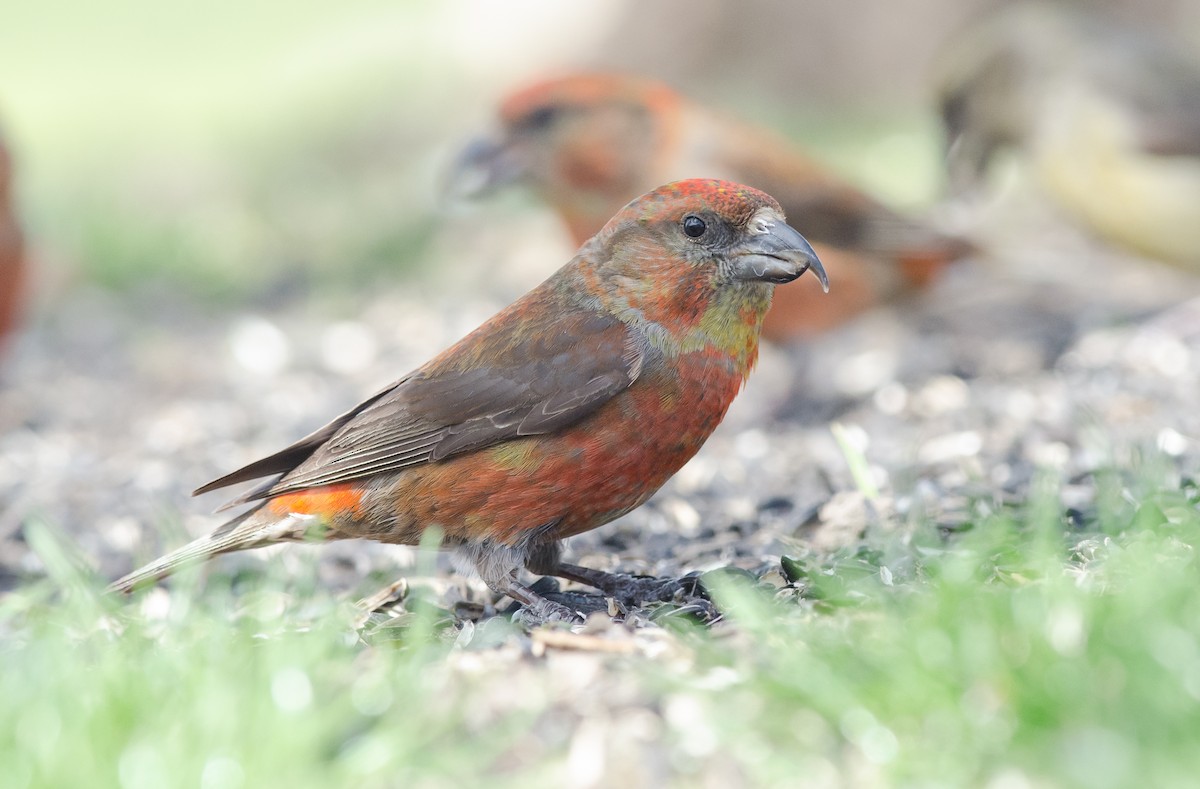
[356,352,742,544]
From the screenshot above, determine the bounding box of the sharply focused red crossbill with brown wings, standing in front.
[113,180,826,620]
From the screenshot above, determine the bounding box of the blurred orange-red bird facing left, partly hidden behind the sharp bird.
[451,74,971,342]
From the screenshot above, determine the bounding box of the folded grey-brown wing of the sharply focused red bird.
[202,304,642,504]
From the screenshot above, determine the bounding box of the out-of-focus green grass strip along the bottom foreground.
[9,458,1200,788]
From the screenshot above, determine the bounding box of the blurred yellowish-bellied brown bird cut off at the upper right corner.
[938,4,1200,267]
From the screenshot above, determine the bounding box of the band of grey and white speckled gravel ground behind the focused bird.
[0,213,1200,619]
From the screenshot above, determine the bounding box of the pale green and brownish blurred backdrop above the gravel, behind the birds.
[0,0,1200,302]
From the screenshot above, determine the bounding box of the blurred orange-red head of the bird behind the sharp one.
[450,74,682,239]
